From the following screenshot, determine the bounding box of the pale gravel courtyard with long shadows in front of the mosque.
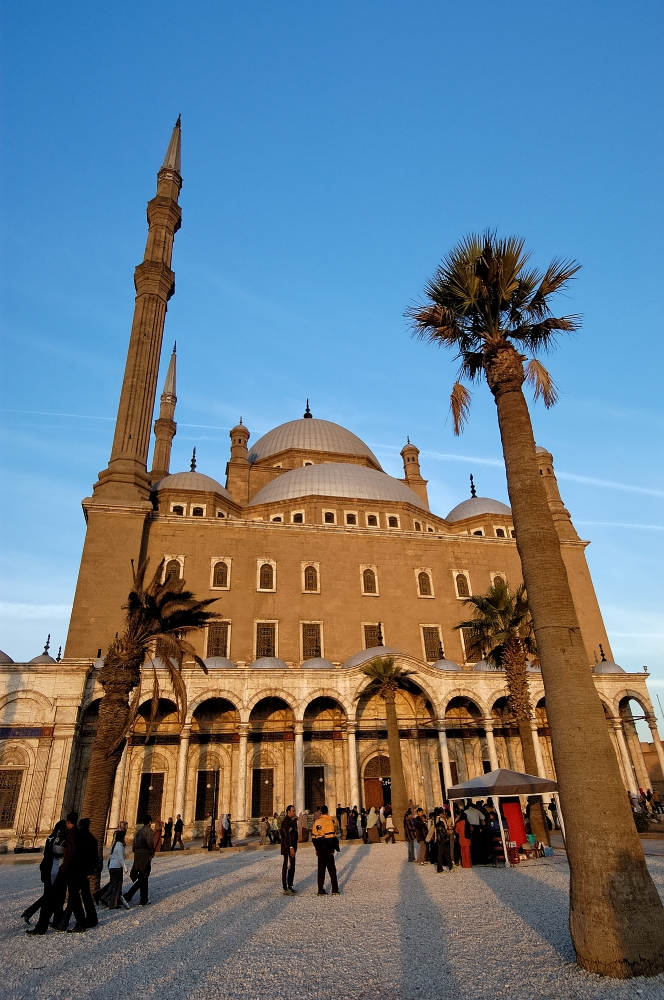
[0,844,664,1000]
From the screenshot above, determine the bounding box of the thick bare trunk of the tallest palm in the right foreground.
[485,347,664,978]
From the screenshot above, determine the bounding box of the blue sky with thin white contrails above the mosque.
[0,0,664,720]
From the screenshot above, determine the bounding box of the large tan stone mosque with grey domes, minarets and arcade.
[0,120,664,849]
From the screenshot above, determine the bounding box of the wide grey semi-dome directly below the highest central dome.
[249,460,426,510]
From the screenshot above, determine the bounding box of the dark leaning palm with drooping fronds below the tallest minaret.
[83,561,217,849]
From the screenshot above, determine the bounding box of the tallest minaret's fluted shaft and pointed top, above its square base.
[93,118,182,504]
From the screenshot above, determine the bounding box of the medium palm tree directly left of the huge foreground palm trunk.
[456,576,549,844]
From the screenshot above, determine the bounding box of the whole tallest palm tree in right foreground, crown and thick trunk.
[408,232,664,978]
